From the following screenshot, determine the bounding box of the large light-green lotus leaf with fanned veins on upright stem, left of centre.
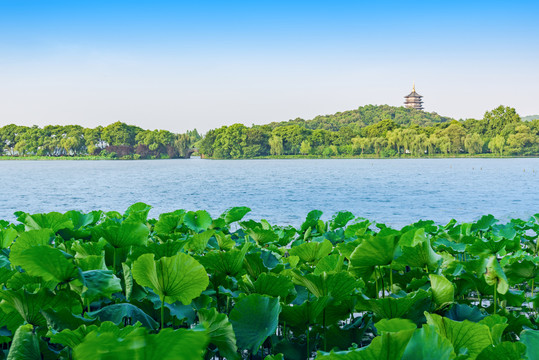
[132,253,209,305]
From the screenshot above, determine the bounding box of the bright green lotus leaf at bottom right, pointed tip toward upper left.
[425,312,492,360]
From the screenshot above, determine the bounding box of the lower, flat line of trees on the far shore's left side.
[0,121,201,159]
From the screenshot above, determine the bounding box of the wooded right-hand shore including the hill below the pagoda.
[199,105,539,159]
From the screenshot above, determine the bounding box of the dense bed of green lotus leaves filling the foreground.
[0,203,539,360]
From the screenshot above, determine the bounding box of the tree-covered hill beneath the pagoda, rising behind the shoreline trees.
[269,105,453,131]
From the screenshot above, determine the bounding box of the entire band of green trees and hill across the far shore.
[0,105,539,160]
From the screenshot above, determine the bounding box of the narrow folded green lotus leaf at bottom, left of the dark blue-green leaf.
[198,308,240,360]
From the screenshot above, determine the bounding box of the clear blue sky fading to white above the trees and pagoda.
[0,0,539,132]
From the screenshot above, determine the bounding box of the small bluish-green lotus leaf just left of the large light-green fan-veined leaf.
[81,270,122,303]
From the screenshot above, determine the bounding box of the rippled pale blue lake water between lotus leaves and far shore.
[0,158,539,226]
